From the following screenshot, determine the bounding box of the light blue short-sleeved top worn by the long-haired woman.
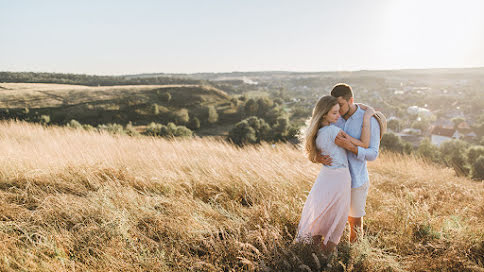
[316,125,348,168]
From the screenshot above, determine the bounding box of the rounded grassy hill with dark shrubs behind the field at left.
[0,83,236,133]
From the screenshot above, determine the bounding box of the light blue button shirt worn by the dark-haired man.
[332,106,380,188]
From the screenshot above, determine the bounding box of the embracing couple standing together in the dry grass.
[297,83,386,251]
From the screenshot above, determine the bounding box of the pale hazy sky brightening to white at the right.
[0,0,484,75]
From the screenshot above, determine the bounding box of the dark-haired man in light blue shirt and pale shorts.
[319,83,380,242]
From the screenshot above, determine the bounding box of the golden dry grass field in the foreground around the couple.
[0,122,484,271]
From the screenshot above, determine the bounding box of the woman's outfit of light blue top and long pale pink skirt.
[296,125,351,245]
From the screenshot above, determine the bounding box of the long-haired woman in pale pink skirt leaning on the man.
[296,95,374,251]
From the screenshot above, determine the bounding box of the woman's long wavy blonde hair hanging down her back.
[304,95,338,163]
